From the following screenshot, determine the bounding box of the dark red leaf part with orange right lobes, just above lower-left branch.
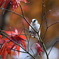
[11,35,26,49]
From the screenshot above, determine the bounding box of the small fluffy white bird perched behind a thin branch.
[29,19,40,39]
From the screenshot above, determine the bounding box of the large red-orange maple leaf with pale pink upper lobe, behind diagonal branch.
[4,29,26,55]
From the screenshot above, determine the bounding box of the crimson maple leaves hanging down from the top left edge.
[0,0,27,9]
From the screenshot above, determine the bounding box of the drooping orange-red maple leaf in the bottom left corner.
[0,42,11,59]
